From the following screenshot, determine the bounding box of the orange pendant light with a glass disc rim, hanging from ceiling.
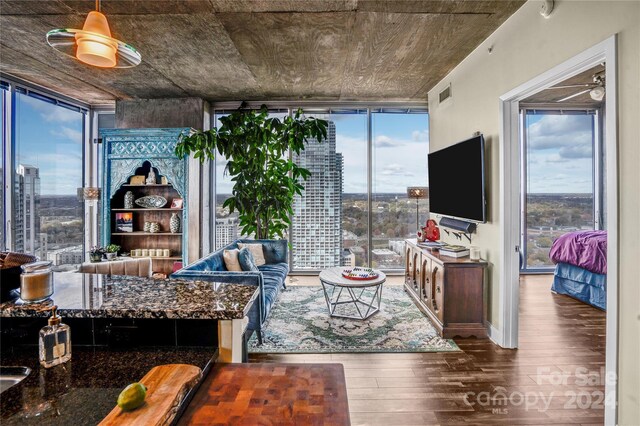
[47,0,142,68]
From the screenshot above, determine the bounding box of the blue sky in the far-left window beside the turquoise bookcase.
[15,93,83,195]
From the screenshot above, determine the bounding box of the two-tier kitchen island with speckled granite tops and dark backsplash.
[0,273,258,425]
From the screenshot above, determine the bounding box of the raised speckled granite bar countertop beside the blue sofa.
[0,272,258,320]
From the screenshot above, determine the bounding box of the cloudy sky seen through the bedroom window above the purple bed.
[526,113,594,193]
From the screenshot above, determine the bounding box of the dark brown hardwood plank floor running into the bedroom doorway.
[250,275,605,425]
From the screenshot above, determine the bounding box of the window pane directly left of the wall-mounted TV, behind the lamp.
[371,110,429,269]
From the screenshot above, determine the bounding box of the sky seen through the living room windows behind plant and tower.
[217,113,429,194]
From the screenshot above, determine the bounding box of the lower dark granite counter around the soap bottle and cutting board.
[0,346,215,426]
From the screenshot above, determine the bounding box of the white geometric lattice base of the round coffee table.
[320,280,382,320]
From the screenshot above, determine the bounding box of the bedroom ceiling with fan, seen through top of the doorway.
[522,65,606,108]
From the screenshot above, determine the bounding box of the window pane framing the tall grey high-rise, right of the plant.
[291,109,369,271]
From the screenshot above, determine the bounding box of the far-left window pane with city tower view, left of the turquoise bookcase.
[11,88,85,270]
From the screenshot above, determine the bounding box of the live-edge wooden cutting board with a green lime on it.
[100,364,202,426]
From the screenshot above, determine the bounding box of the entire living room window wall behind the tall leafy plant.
[215,107,429,271]
